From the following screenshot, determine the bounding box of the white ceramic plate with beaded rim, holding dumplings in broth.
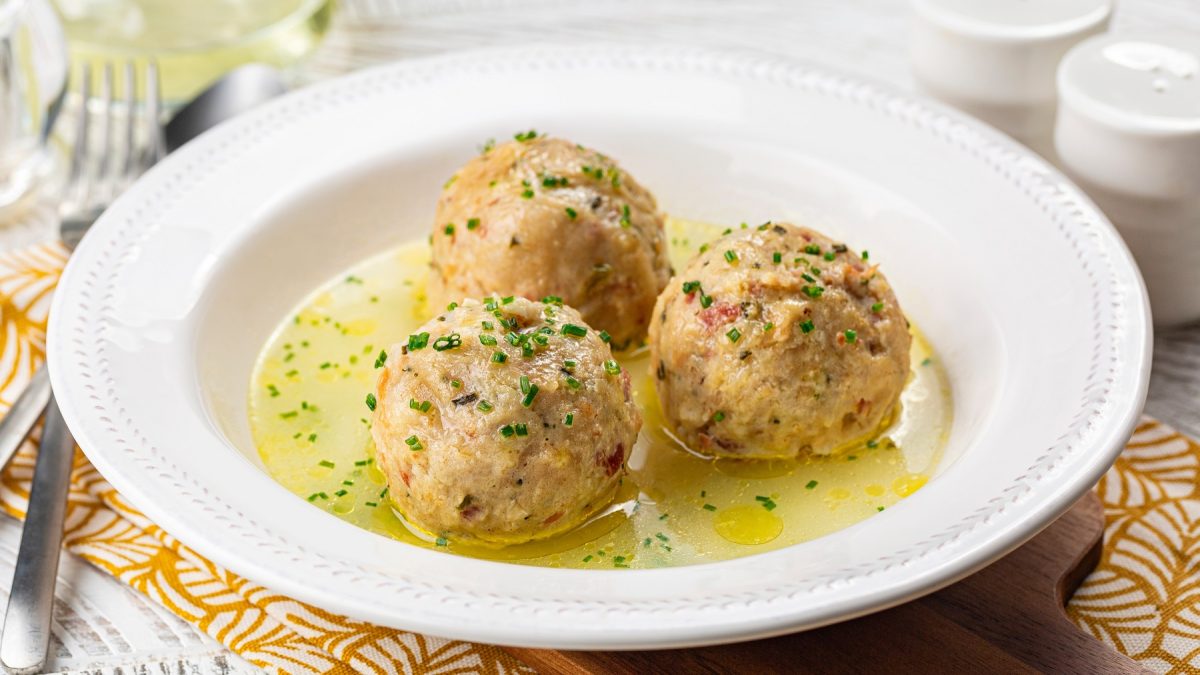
[49,48,1151,649]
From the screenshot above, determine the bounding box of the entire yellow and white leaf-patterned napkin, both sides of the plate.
[0,244,1200,674]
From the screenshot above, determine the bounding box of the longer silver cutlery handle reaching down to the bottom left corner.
[0,396,74,674]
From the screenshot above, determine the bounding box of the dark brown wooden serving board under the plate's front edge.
[506,492,1144,675]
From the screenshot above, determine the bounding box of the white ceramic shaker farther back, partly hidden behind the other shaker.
[910,0,1114,159]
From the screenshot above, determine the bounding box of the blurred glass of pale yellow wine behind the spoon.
[54,0,334,106]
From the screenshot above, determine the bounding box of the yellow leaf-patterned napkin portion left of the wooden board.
[0,244,533,675]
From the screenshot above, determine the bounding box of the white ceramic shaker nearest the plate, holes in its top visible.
[1055,35,1200,325]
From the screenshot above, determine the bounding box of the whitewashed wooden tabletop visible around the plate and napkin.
[9,0,1200,674]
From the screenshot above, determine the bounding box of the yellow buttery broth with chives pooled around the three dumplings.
[250,220,952,568]
